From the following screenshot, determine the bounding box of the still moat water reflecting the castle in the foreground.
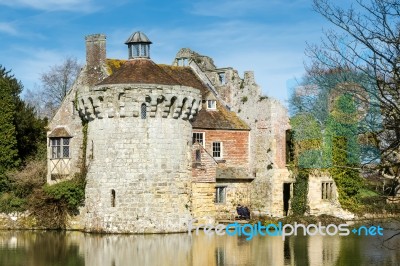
[0,221,400,266]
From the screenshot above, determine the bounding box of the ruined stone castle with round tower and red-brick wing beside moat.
[47,32,294,233]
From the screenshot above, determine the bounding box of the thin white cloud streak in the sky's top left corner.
[0,0,94,12]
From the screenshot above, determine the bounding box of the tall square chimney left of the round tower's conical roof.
[85,34,106,85]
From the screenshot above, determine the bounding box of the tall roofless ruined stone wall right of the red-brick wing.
[194,54,294,216]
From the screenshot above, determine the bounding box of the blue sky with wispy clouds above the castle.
[0,0,340,104]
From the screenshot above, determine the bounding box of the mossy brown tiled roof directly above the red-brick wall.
[192,101,250,130]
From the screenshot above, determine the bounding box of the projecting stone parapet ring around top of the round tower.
[75,84,201,121]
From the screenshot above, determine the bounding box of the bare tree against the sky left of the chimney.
[25,57,81,118]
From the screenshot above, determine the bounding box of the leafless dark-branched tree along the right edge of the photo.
[306,0,400,195]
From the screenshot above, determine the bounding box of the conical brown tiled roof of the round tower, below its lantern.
[99,58,182,85]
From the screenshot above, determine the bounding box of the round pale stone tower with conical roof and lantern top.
[77,32,201,233]
